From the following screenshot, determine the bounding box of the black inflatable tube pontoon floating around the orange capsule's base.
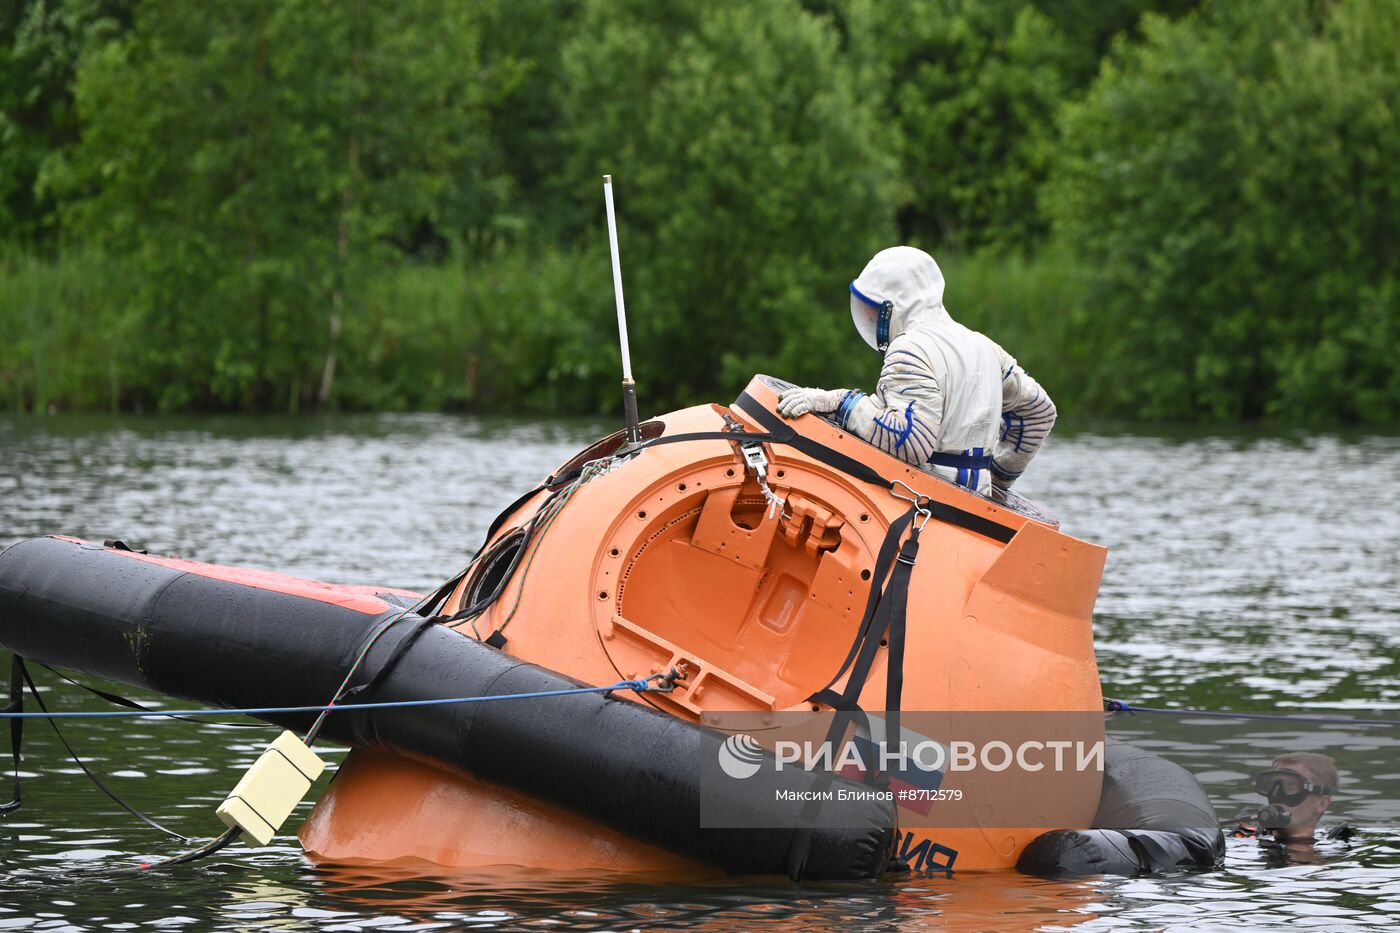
[0,538,1224,880]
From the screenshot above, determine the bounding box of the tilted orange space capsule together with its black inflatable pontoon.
[0,377,1224,878]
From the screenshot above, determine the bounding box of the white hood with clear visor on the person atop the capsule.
[851,247,949,350]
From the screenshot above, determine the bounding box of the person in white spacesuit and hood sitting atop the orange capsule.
[778,247,1056,493]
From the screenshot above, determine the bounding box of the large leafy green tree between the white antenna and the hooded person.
[563,0,893,406]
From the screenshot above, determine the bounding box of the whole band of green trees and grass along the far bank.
[0,0,1400,423]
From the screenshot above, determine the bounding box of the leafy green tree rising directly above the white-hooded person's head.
[848,0,1071,248]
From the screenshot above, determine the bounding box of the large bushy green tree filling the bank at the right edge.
[1046,0,1400,422]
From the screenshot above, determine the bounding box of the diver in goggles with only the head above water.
[1231,752,1355,846]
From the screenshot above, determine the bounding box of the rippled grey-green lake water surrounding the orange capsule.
[0,415,1400,930]
